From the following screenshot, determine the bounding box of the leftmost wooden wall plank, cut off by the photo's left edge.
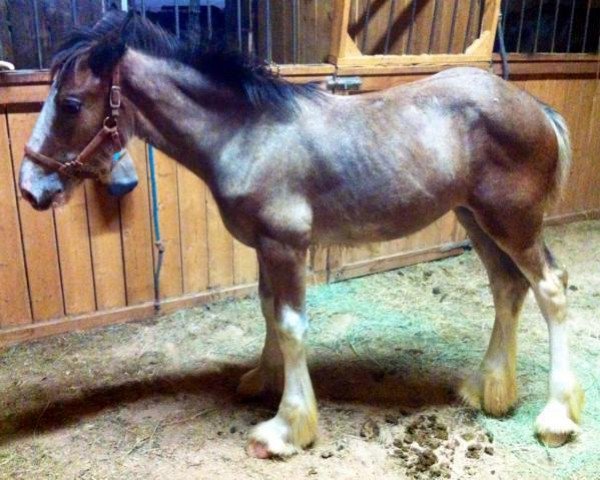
[0,108,32,328]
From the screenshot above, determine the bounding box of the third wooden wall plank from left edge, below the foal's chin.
[54,185,96,315]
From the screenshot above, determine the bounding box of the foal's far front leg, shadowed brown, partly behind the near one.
[238,259,283,397]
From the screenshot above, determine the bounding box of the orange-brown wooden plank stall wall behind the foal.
[0,60,600,344]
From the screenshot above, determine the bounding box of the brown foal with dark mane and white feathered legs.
[19,12,584,458]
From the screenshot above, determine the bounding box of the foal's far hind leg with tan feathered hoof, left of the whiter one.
[456,208,529,416]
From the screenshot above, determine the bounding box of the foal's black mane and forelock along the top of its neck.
[51,10,321,115]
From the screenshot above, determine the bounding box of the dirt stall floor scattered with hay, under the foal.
[0,222,600,480]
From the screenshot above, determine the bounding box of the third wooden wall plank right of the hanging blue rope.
[206,189,234,288]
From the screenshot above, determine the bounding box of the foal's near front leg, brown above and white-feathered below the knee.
[248,239,318,458]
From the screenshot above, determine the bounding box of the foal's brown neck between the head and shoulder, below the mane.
[121,51,244,181]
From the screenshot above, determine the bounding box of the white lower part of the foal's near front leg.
[249,305,317,458]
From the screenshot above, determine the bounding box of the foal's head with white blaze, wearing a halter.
[19,23,138,210]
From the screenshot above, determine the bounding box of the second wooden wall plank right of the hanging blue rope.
[177,165,208,293]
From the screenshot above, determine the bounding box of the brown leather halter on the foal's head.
[25,67,123,178]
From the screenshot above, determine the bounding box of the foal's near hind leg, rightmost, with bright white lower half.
[466,210,584,446]
